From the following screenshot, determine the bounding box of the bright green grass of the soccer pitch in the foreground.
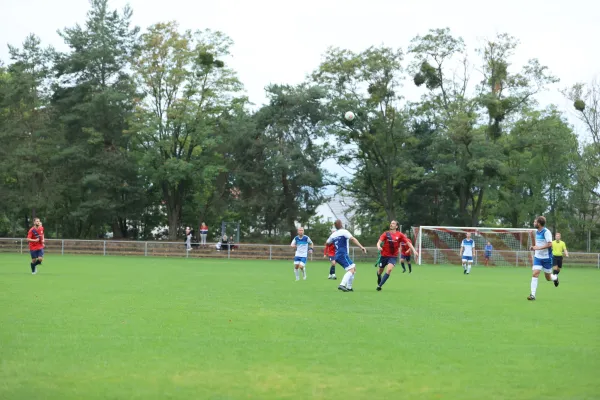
[0,255,600,400]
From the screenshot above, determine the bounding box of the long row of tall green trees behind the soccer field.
[0,0,600,248]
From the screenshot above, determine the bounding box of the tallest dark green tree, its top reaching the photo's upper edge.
[53,0,145,237]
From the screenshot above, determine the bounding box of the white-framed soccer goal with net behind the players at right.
[412,226,535,267]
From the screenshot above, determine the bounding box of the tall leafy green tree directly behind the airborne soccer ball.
[313,47,422,220]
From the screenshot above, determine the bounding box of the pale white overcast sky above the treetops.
[0,0,600,133]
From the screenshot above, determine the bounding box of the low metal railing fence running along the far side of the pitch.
[0,238,600,269]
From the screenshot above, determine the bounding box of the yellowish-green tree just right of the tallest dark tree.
[134,22,242,239]
